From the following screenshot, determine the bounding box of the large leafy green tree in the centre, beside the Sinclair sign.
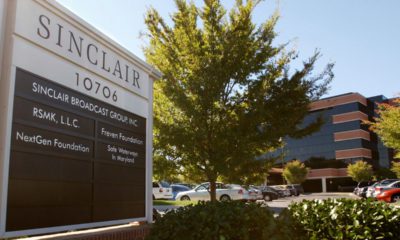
[144,0,333,200]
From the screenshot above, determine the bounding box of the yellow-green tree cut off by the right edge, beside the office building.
[366,98,400,158]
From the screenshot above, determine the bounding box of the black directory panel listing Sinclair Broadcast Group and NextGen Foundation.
[6,68,146,232]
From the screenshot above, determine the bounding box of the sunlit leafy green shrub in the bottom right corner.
[281,199,400,240]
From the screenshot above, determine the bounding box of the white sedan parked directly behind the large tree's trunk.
[176,182,249,201]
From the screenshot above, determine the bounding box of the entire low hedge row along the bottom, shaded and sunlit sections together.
[146,199,400,240]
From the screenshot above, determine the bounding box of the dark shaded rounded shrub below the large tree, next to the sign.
[146,201,293,240]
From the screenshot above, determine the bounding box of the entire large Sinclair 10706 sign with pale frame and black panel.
[0,0,161,237]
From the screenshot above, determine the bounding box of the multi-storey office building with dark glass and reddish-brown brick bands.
[272,93,393,192]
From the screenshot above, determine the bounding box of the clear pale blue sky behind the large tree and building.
[57,0,400,98]
